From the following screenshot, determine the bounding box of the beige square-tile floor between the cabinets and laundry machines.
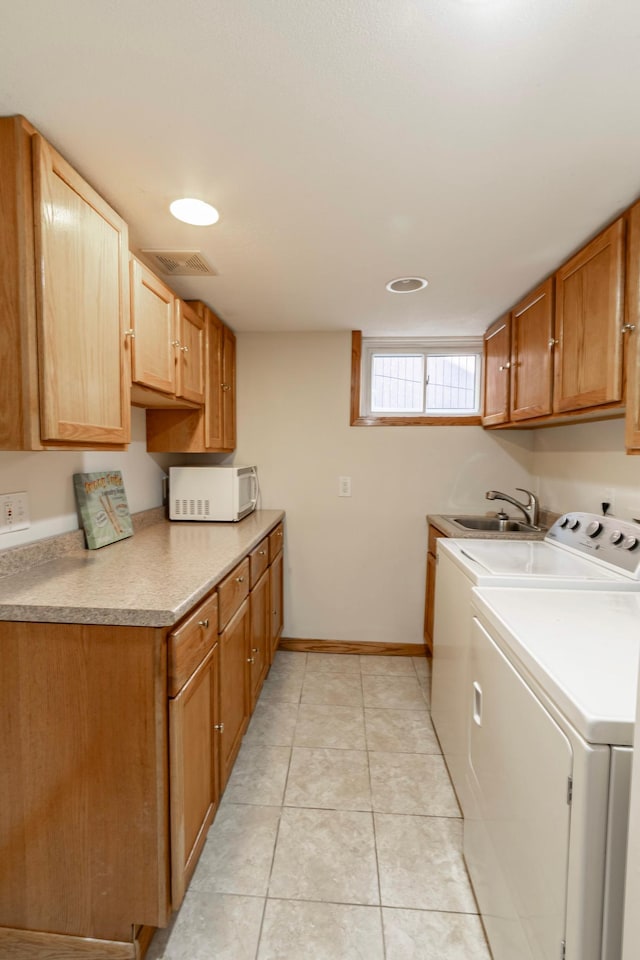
[147,651,491,960]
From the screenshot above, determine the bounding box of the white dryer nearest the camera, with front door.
[464,588,640,960]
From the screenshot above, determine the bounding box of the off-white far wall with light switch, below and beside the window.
[235,333,534,643]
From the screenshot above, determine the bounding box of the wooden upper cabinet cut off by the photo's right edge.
[624,201,640,453]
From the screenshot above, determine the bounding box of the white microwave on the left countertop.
[169,466,258,520]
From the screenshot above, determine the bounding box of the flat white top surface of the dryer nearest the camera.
[473,587,640,746]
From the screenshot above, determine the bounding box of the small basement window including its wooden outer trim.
[351,331,482,426]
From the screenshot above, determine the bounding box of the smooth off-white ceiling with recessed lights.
[0,0,640,336]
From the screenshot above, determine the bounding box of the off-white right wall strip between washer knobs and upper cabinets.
[532,419,640,520]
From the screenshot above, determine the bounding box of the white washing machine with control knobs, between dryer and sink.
[431,513,640,815]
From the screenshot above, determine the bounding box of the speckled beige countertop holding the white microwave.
[0,510,284,627]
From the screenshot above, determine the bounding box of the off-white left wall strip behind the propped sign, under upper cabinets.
[0,407,177,550]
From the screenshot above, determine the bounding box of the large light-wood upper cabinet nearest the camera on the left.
[0,117,130,450]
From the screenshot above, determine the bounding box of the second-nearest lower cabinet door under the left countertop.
[219,599,250,790]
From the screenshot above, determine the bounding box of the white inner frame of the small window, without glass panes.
[360,337,483,420]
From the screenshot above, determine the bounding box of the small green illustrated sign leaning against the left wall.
[73,470,133,550]
